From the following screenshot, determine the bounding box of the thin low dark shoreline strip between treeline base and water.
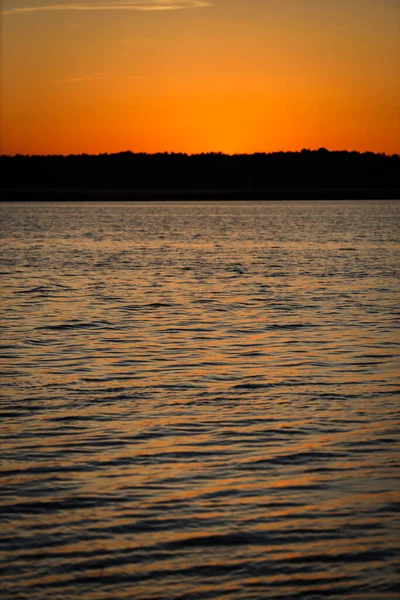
[0,188,400,202]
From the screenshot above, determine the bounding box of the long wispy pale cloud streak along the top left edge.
[0,0,212,15]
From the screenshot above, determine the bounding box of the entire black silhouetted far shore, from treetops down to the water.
[0,148,400,201]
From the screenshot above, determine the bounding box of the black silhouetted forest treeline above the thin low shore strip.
[0,148,400,197]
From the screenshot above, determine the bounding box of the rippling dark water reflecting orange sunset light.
[0,202,400,600]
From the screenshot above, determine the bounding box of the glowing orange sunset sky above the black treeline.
[0,0,400,154]
